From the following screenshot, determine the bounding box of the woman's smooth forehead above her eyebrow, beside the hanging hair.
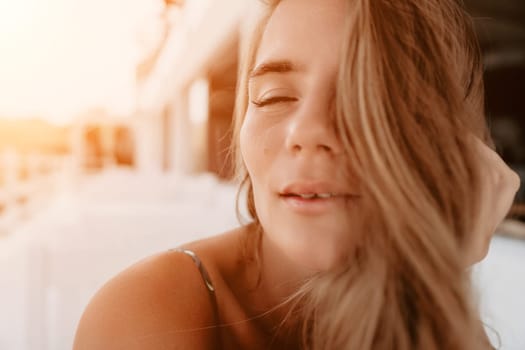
[255,0,345,67]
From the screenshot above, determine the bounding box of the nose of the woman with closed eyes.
[285,98,341,155]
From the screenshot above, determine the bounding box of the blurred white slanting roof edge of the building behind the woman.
[137,0,249,110]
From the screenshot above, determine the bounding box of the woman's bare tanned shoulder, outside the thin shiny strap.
[73,246,218,350]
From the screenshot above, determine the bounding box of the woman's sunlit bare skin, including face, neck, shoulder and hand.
[74,0,519,350]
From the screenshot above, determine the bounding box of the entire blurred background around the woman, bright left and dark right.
[0,0,525,350]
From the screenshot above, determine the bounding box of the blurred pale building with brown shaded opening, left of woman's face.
[135,0,250,177]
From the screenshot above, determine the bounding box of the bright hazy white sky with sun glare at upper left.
[0,0,161,121]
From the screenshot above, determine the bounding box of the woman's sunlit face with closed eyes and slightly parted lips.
[240,0,357,271]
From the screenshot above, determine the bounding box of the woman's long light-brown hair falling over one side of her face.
[234,0,491,350]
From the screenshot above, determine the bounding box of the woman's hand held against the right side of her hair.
[467,137,520,265]
